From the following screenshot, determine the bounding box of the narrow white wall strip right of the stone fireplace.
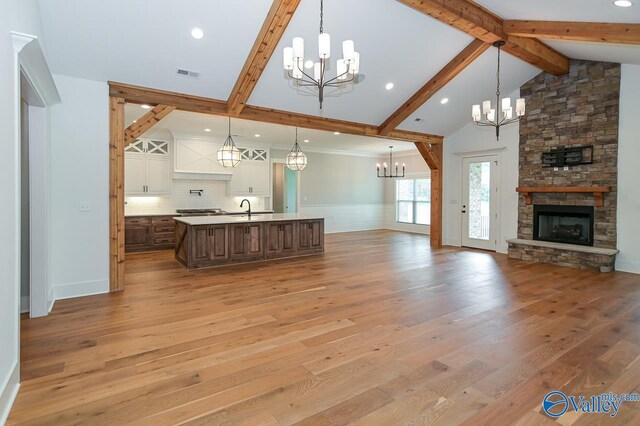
[616,65,640,273]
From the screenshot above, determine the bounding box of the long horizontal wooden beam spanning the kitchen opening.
[109,82,443,144]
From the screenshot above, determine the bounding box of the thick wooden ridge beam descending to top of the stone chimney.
[398,0,569,75]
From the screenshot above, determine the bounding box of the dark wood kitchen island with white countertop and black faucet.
[174,213,324,269]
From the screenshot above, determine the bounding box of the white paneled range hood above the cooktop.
[174,140,233,175]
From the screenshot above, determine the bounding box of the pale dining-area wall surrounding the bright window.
[378,149,430,234]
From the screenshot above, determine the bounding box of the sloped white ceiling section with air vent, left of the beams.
[40,0,271,100]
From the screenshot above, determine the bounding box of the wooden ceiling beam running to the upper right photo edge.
[504,21,640,44]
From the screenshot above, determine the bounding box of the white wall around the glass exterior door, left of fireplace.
[442,92,520,253]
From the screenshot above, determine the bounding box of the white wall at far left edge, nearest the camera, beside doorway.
[0,0,42,424]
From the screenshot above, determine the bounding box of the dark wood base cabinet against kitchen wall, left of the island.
[124,216,175,253]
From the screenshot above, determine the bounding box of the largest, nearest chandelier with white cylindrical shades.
[284,0,360,109]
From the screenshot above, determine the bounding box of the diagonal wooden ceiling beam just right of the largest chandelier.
[380,39,490,135]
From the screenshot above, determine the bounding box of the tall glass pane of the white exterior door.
[467,161,491,240]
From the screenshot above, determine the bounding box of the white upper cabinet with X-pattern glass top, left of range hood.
[124,139,171,195]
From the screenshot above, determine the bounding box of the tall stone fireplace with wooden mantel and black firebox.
[509,60,620,270]
